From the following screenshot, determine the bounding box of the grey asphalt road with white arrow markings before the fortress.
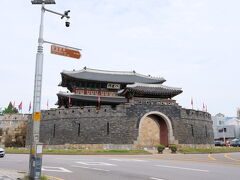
[0,153,240,180]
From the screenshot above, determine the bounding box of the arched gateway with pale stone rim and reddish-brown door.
[137,111,174,147]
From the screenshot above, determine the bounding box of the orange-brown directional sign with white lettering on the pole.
[51,45,81,59]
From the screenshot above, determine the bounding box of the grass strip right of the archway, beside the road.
[178,147,240,154]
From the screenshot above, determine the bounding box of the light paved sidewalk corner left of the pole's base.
[0,169,25,180]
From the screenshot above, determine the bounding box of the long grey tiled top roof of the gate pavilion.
[62,68,166,84]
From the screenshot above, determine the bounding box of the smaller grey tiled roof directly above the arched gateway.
[118,83,183,97]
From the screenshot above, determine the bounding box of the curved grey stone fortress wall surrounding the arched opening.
[32,98,213,149]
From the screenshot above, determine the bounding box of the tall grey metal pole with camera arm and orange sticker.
[29,0,74,180]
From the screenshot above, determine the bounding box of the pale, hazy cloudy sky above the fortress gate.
[0,0,240,116]
